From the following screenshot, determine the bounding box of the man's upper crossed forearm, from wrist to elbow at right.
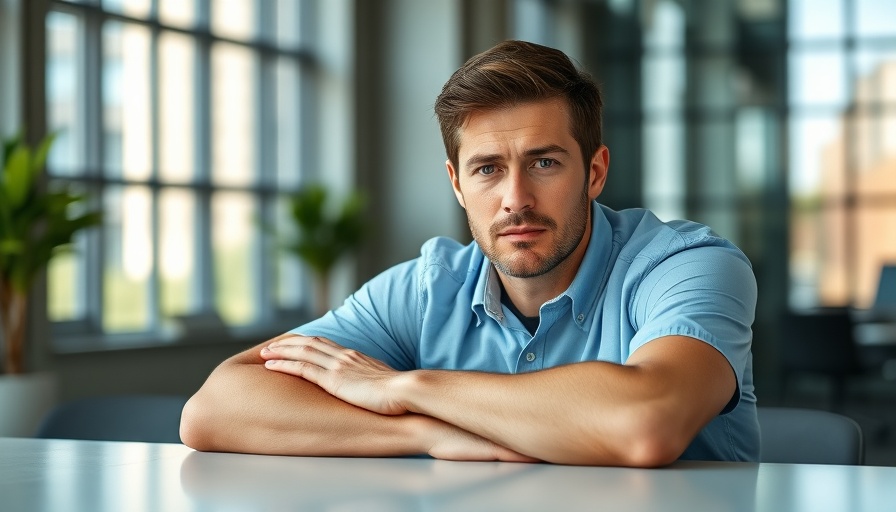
[399,363,651,465]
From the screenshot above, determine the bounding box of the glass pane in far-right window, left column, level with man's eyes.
[789,116,846,200]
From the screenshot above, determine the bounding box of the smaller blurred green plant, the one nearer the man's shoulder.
[283,184,367,314]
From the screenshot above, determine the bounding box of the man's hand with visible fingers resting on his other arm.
[260,336,407,415]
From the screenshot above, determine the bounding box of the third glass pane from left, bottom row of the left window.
[159,189,199,317]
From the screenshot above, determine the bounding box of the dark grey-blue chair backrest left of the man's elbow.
[35,395,187,443]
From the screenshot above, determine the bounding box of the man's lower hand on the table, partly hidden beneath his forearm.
[421,416,540,462]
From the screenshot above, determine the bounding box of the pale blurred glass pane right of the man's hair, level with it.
[641,53,686,112]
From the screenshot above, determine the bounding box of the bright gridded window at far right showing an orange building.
[788,0,896,307]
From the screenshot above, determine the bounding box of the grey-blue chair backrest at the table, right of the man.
[758,407,865,465]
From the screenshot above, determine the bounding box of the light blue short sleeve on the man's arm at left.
[290,259,421,370]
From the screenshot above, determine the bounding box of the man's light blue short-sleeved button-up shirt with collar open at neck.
[292,202,759,461]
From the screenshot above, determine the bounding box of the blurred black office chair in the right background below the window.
[780,308,865,411]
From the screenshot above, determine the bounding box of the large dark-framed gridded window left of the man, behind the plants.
[46,0,313,350]
